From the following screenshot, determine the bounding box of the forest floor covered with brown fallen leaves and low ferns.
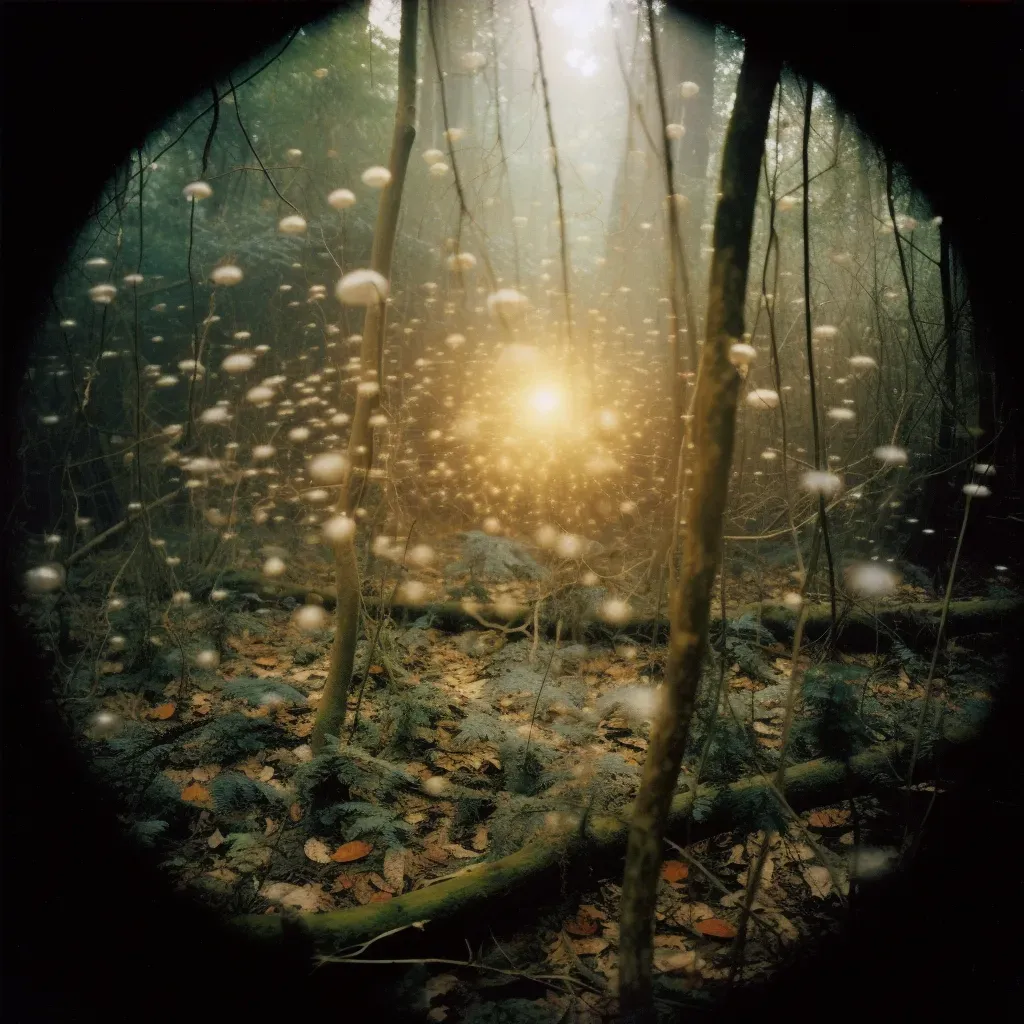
[68,532,1011,1021]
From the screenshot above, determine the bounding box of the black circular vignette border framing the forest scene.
[0,2,1024,1022]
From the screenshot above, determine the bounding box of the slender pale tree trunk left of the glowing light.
[309,0,419,754]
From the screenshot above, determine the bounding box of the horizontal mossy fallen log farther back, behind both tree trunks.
[207,572,1024,650]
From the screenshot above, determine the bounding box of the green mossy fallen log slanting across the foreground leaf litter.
[231,731,974,954]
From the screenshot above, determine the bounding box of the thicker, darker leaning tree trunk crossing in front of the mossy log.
[618,44,780,1021]
